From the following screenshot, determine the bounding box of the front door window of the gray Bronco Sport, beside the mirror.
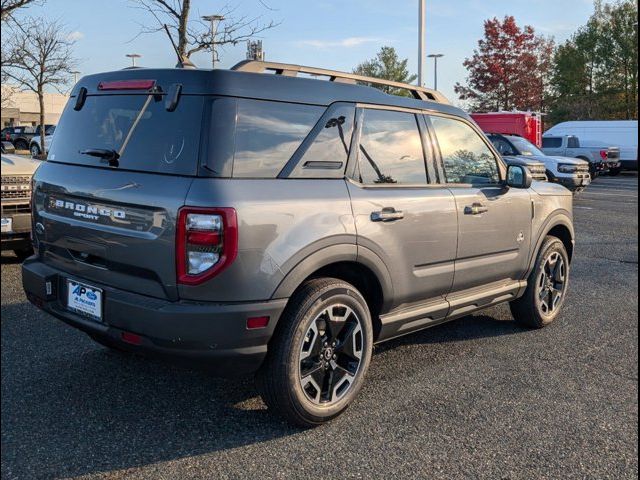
[430,116,500,184]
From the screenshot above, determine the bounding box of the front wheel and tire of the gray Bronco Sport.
[509,236,569,328]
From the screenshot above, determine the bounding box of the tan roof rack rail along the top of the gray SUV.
[231,60,449,104]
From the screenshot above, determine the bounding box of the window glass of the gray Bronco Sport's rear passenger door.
[358,109,427,185]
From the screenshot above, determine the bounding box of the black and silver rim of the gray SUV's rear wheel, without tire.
[299,304,364,405]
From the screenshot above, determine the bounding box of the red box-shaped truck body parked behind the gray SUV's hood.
[471,112,542,147]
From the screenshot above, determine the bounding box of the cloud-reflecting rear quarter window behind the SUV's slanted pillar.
[233,99,325,178]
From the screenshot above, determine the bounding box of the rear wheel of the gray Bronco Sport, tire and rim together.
[256,278,373,427]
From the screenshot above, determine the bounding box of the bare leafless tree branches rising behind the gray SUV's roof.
[131,0,278,60]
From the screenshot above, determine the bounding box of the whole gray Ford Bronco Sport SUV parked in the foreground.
[22,61,574,426]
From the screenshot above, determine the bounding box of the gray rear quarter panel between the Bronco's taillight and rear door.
[179,178,357,302]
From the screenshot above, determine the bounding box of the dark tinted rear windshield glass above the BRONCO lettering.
[48,95,204,175]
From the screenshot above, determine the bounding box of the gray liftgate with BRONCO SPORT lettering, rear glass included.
[34,85,204,300]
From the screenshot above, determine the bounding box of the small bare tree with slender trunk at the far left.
[2,18,76,154]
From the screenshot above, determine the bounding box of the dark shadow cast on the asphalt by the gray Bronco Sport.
[2,303,523,478]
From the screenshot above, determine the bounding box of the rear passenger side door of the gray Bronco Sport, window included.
[348,107,457,319]
